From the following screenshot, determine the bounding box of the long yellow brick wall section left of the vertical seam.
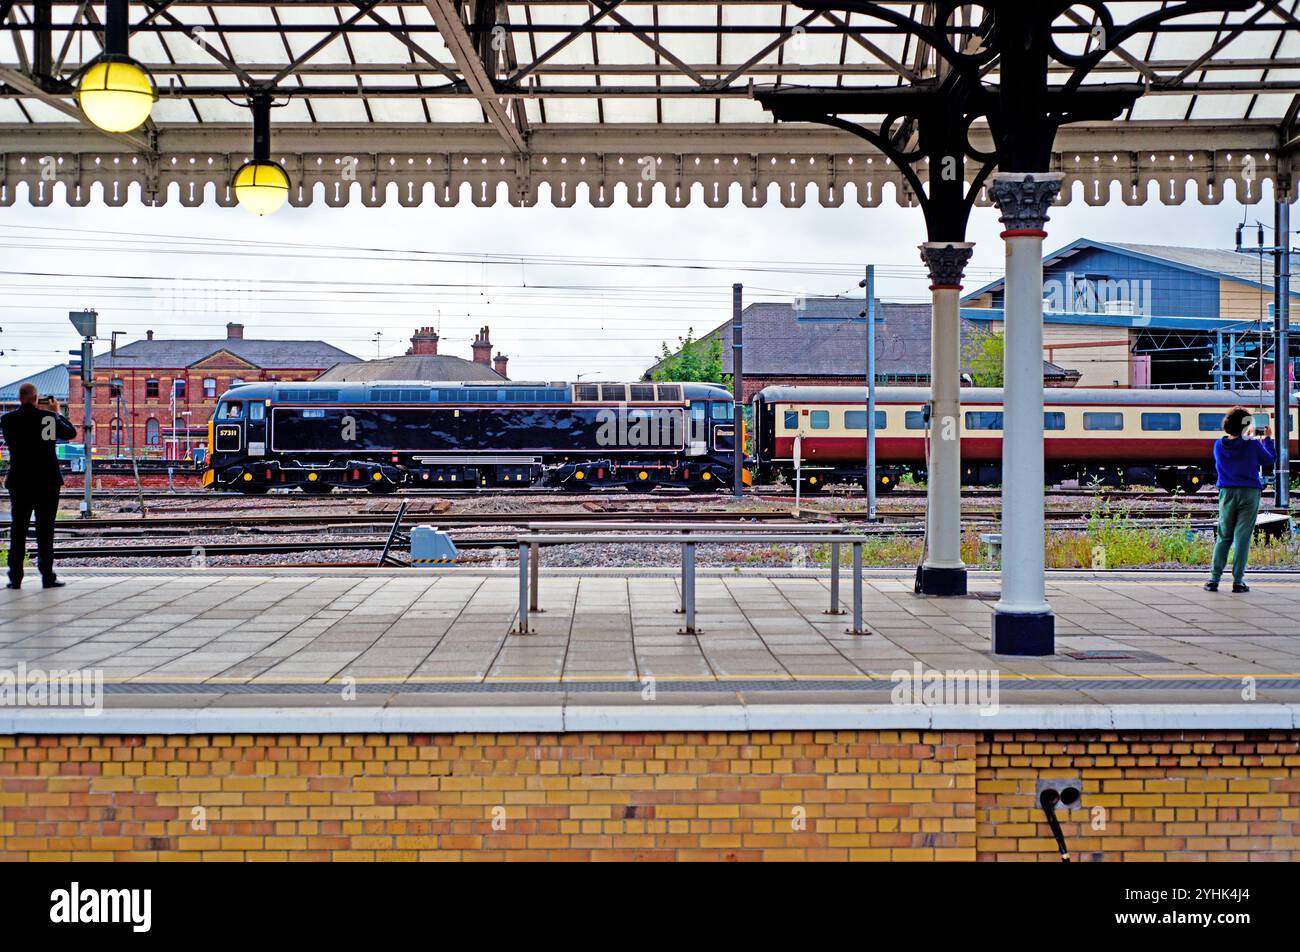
[0,731,975,860]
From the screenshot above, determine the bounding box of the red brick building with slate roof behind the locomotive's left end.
[66,324,356,458]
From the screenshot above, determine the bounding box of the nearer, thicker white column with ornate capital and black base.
[989,172,1062,655]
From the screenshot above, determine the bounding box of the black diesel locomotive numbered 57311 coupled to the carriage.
[203,381,736,493]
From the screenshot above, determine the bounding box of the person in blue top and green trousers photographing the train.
[1205,407,1278,592]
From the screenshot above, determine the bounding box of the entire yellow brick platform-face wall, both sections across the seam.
[0,731,1300,862]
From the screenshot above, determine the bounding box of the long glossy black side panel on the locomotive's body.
[272,407,685,453]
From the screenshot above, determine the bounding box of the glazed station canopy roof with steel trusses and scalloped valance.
[0,0,1300,205]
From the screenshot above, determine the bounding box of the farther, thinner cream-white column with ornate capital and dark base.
[917,242,975,596]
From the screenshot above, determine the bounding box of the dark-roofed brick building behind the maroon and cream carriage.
[645,298,1079,402]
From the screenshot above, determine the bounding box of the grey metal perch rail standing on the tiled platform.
[511,524,870,635]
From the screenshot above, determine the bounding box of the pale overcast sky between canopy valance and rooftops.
[0,178,1273,382]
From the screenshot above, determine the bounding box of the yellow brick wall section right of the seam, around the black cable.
[976,731,1300,862]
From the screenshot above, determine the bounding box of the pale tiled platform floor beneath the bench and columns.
[0,568,1300,707]
